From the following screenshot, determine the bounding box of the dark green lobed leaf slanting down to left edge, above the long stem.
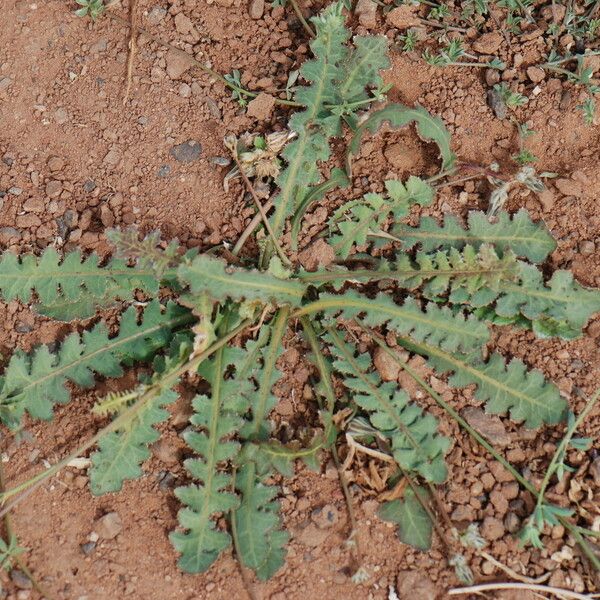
[0,300,194,426]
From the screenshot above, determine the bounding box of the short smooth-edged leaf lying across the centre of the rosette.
[178,254,305,306]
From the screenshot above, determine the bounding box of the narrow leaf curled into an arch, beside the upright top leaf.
[346,104,456,175]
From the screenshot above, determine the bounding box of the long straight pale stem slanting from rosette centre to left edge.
[0,319,252,517]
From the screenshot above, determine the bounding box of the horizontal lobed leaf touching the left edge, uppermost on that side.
[0,247,159,320]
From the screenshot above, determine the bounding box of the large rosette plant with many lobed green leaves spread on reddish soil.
[0,3,600,579]
